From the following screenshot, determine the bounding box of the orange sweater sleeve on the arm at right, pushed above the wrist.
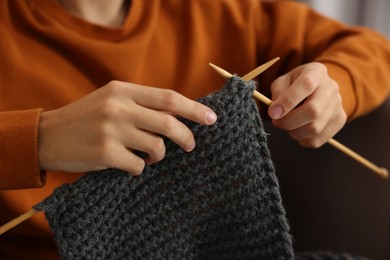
[258,2,390,120]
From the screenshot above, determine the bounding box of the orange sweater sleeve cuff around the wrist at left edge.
[0,109,45,189]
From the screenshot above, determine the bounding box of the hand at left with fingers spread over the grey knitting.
[39,81,217,175]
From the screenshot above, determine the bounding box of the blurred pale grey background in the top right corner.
[299,0,390,38]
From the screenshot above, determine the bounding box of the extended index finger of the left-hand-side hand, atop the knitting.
[129,87,217,125]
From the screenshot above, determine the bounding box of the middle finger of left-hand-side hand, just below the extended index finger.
[132,107,195,152]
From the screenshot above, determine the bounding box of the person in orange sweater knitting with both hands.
[0,0,390,259]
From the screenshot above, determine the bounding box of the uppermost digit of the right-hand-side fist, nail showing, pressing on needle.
[268,68,321,119]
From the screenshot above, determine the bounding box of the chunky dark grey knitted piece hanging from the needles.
[34,77,366,260]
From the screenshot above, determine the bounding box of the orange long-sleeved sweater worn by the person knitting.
[0,0,390,259]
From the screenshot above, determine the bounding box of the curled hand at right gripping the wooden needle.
[268,62,347,148]
